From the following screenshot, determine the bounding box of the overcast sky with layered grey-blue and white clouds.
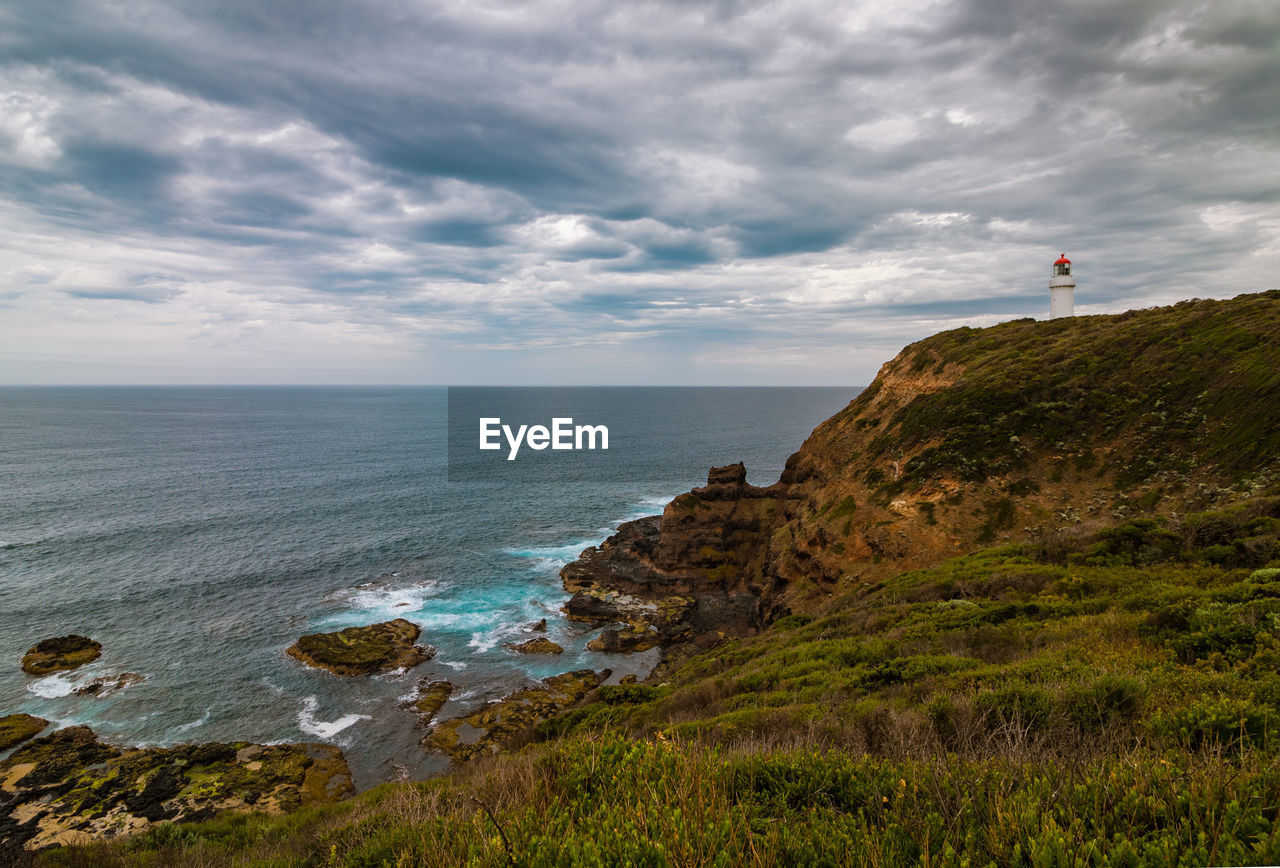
[0,0,1280,385]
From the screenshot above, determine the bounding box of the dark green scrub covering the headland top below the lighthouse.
[865,289,1280,488]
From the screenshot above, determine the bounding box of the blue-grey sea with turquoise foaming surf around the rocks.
[0,388,856,786]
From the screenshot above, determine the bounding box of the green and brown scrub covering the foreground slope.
[35,497,1280,867]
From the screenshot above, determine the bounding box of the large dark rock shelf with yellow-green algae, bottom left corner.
[0,726,355,864]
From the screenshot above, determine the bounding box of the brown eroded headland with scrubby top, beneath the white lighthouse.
[562,292,1280,644]
